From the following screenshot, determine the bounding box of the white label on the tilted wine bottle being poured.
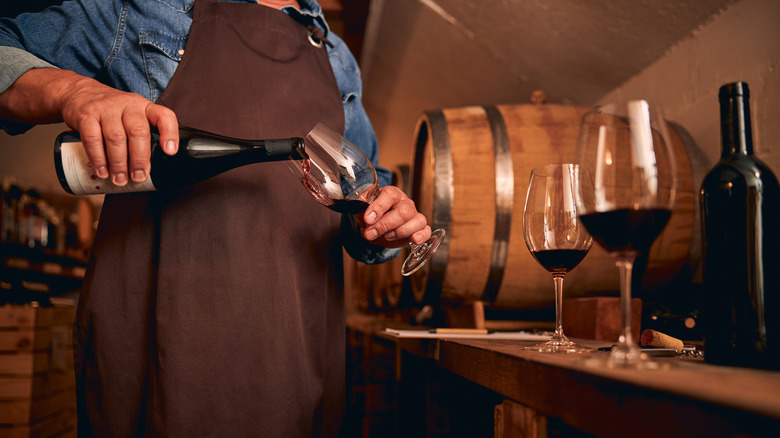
[60,142,156,195]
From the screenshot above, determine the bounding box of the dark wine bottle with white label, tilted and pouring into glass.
[54,128,304,195]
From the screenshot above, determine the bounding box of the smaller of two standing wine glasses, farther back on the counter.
[523,164,593,353]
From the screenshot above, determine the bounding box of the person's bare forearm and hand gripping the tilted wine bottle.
[0,68,179,186]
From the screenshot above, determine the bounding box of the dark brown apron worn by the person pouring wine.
[76,0,344,437]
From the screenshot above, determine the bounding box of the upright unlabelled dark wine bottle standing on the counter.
[700,82,780,369]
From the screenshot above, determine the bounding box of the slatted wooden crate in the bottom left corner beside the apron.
[0,305,76,438]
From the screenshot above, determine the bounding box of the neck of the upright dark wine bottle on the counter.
[720,87,753,158]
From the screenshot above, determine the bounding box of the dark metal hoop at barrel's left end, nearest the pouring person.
[426,110,455,296]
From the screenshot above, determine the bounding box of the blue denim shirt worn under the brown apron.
[0,0,399,263]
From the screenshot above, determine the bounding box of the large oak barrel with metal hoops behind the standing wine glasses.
[411,104,700,309]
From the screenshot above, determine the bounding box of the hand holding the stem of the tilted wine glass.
[358,186,431,248]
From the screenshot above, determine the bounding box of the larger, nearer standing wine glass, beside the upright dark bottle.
[577,100,677,369]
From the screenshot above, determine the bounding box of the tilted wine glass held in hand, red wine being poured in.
[288,123,445,276]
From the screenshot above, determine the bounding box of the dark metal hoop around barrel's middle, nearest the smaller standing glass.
[482,106,515,303]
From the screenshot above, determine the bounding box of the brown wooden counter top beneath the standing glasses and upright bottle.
[348,318,780,437]
